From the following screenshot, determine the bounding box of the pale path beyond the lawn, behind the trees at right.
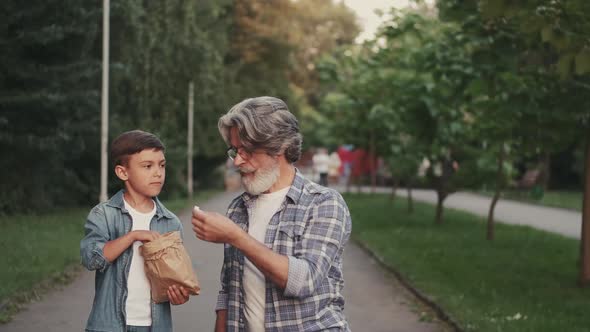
[336,186,582,239]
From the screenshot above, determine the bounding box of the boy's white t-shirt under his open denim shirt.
[125,201,156,326]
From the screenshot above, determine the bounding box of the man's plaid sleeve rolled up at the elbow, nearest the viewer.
[284,193,351,298]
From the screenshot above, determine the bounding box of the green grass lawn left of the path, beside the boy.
[0,191,215,323]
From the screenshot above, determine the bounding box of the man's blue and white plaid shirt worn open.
[216,171,351,331]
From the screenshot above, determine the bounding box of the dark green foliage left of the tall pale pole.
[0,1,101,214]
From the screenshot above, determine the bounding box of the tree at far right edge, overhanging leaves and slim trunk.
[479,0,590,286]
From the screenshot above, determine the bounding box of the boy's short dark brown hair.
[111,130,166,166]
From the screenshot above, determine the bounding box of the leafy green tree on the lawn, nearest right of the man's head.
[381,11,472,224]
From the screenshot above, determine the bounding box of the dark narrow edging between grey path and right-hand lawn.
[352,238,464,332]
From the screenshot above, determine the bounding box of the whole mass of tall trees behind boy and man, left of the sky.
[0,0,358,214]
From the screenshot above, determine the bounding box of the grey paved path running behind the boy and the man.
[0,193,450,332]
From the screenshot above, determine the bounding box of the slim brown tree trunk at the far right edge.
[579,134,590,287]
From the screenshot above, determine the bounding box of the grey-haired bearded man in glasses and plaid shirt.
[192,97,351,331]
